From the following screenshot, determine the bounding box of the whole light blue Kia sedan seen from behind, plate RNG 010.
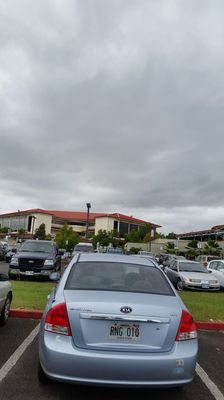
[38,253,198,387]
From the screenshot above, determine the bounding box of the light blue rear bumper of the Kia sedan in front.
[39,330,198,387]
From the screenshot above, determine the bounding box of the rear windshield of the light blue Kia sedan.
[65,262,174,296]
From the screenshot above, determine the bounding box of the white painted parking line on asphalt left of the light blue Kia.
[0,324,40,383]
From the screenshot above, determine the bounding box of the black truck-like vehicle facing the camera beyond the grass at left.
[9,240,62,278]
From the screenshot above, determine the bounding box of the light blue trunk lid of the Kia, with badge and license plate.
[64,290,182,352]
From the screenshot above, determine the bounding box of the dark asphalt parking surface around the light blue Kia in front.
[0,318,224,400]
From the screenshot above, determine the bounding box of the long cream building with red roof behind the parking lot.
[0,208,160,237]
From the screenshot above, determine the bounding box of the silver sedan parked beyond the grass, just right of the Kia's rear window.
[165,259,220,291]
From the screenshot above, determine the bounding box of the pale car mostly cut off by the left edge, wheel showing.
[0,273,12,325]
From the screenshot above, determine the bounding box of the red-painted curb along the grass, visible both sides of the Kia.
[10,309,224,331]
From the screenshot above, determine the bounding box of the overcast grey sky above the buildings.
[0,0,224,233]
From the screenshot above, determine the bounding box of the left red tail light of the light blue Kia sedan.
[44,303,71,336]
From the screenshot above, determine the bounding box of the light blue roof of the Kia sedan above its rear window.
[78,253,157,268]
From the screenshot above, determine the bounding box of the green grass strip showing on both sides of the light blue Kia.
[11,281,224,321]
